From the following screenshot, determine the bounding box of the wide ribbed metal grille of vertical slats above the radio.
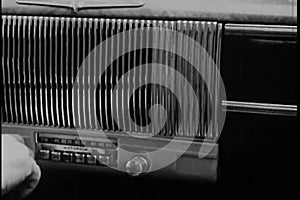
[1,15,222,139]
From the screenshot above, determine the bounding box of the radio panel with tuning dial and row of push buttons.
[35,133,118,166]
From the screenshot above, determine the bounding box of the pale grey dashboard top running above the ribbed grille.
[2,0,297,24]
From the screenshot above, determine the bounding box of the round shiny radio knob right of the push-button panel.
[125,156,149,176]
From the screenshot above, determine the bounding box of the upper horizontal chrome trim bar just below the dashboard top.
[224,24,297,36]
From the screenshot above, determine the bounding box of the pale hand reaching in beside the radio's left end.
[1,134,41,199]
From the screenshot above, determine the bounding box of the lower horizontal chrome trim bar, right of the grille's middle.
[222,101,297,116]
